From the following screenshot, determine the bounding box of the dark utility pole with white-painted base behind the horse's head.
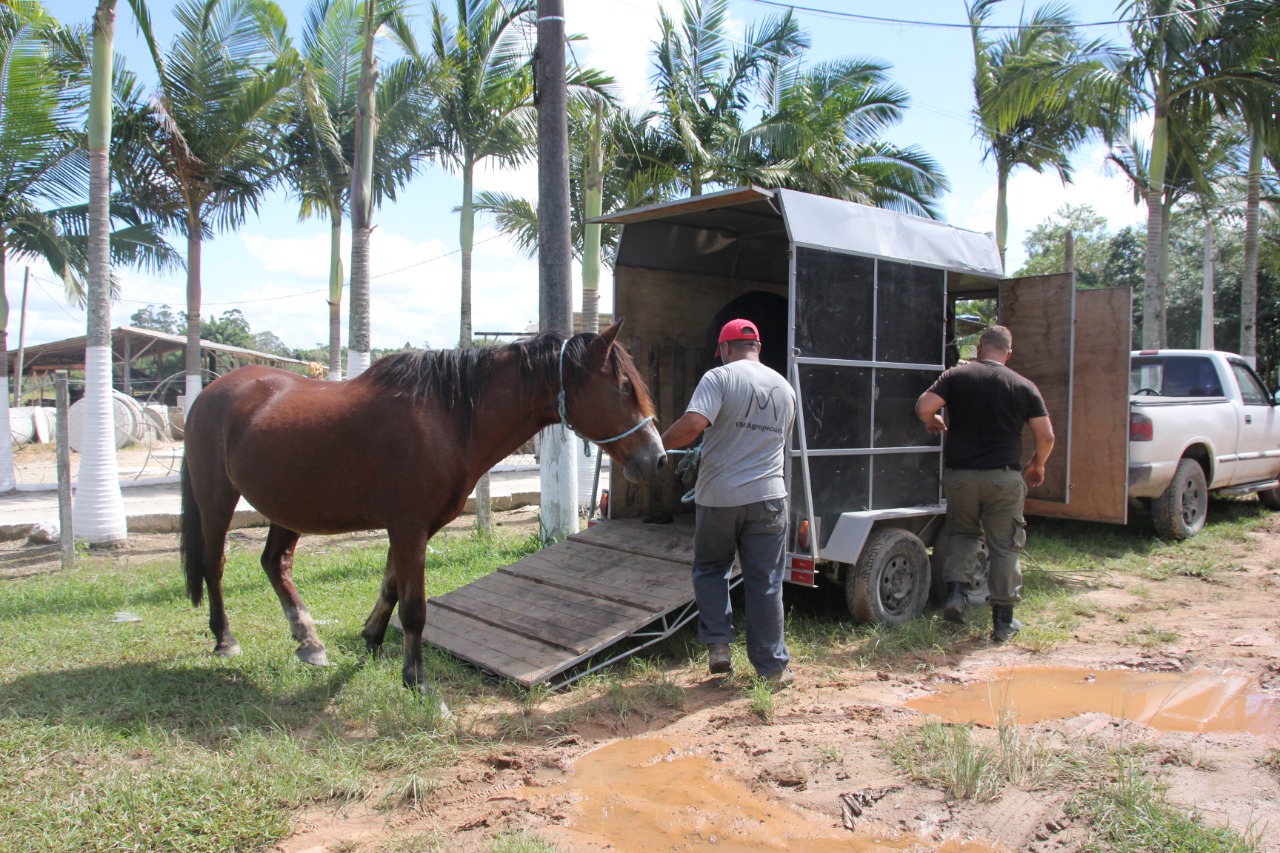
[534,0,577,540]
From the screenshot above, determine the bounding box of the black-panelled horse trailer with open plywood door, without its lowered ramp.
[599,187,1129,624]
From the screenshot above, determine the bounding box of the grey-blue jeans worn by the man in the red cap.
[694,498,791,678]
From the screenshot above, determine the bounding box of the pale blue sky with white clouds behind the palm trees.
[17,0,1144,348]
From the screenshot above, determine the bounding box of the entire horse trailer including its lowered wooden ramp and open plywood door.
[424,187,1129,686]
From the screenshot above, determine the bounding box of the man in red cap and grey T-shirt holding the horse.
[662,319,796,686]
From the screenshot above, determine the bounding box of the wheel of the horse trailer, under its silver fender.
[845,528,929,625]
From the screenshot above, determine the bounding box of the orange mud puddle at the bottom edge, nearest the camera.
[526,739,996,853]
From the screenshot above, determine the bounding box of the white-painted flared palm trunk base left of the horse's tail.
[73,347,126,544]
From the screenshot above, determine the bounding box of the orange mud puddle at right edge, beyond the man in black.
[906,667,1280,734]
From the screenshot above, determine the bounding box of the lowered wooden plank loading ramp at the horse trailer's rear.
[422,515,721,686]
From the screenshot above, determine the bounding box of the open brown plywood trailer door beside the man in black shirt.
[1000,273,1129,524]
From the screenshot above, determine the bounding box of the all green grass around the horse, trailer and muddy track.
[0,502,1280,852]
